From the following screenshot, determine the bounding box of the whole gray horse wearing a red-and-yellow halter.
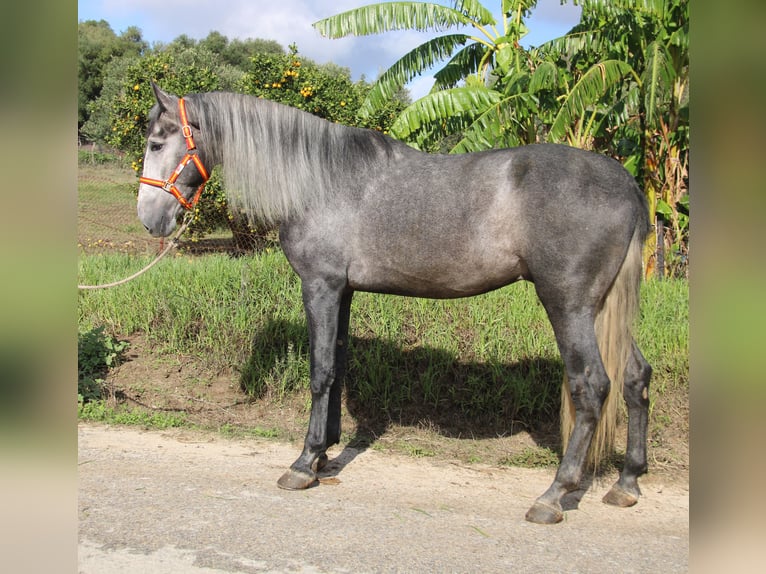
[138,86,651,523]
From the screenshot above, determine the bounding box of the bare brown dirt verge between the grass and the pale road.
[99,336,689,484]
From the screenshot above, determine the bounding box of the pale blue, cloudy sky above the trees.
[77,0,580,99]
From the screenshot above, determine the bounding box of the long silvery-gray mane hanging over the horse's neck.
[186,92,396,222]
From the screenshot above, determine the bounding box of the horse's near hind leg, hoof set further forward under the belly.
[526,311,610,524]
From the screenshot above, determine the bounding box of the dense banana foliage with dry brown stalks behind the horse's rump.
[544,0,689,276]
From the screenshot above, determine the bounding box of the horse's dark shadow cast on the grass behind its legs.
[240,320,563,460]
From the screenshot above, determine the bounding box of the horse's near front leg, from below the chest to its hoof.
[277,280,343,490]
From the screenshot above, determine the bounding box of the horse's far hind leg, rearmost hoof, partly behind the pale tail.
[603,341,652,506]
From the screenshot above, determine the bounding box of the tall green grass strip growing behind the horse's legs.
[78,249,689,438]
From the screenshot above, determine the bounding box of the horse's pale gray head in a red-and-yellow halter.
[138,83,208,237]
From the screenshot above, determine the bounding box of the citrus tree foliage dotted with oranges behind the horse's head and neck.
[83,38,404,248]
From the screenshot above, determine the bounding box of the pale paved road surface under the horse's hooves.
[79,425,689,574]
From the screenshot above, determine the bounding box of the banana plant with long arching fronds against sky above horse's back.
[314,0,537,152]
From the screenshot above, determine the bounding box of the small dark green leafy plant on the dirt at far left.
[77,326,130,403]
